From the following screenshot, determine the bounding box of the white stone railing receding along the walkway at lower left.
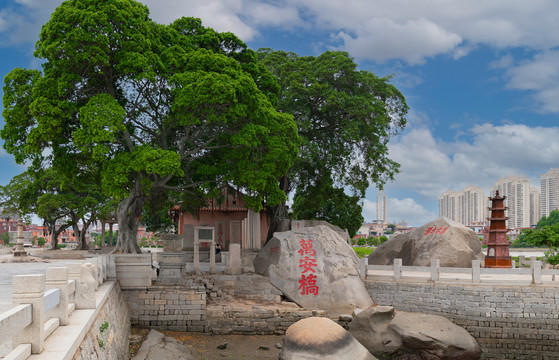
[0,256,108,360]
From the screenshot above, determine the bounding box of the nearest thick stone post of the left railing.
[12,274,45,354]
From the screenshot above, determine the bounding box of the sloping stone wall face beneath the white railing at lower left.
[73,286,130,360]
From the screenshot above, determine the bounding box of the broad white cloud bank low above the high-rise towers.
[388,124,559,200]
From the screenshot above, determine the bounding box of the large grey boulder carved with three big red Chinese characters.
[254,226,373,314]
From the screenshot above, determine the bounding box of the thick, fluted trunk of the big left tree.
[113,187,145,254]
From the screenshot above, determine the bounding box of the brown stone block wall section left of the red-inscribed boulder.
[123,286,206,332]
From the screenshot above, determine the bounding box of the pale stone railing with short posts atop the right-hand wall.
[359,257,559,285]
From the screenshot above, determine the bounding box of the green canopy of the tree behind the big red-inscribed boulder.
[258,49,408,238]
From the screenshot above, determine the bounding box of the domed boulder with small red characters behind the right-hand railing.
[369,218,484,268]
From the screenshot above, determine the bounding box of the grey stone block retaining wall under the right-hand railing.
[365,279,559,359]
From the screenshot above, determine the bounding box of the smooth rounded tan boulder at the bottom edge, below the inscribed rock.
[279,317,375,360]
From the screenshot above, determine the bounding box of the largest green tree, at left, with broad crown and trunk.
[0,0,299,253]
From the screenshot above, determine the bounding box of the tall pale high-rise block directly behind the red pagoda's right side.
[490,175,539,229]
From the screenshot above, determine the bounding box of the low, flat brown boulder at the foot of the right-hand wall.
[349,306,481,360]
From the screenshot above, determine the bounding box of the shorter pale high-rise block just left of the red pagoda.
[439,185,488,225]
